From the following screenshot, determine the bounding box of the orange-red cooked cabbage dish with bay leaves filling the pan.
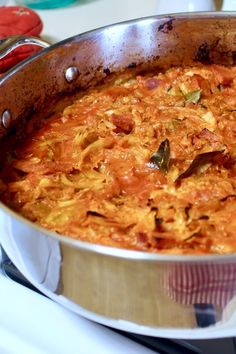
[1,65,236,254]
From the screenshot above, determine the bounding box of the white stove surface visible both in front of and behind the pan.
[0,0,236,354]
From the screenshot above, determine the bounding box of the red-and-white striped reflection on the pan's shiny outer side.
[165,263,236,308]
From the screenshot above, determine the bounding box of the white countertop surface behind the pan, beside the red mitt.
[8,0,236,43]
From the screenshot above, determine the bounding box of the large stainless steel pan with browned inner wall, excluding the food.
[0,13,236,338]
